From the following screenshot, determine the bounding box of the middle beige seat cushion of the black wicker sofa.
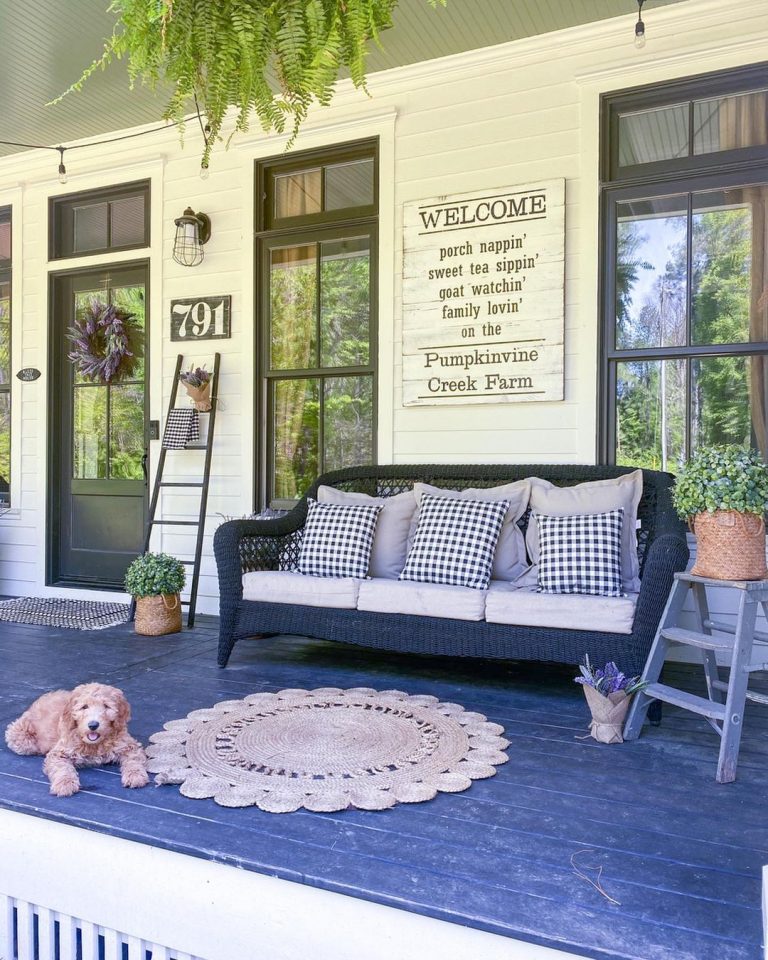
[357,579,487,620]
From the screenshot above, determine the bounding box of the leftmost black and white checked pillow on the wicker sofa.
[296,498,382,580]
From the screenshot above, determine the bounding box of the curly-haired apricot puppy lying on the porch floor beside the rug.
[5,683,149,797]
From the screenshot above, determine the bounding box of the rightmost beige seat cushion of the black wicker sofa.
[485,582,637,633]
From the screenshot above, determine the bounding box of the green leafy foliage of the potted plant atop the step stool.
[672,445,768,520]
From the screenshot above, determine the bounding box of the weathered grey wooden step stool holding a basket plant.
[624,573,768,783]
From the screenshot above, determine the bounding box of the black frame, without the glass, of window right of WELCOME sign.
[597,64,768,464]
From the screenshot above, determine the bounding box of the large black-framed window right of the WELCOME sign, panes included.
[600,66,768,472]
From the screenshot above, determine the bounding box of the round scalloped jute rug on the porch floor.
[147,687,509,813]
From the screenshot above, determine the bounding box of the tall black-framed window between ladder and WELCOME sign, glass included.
[256,141,378,508]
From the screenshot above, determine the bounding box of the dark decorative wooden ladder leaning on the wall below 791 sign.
[129,353,221,627]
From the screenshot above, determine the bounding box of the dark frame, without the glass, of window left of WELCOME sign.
[254,137,379,511]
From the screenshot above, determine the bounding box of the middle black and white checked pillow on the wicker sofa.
[398,493,509,590]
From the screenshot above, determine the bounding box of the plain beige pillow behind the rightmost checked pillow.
[525,470,643,593]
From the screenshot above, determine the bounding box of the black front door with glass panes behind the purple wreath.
[49,264,148,587]
